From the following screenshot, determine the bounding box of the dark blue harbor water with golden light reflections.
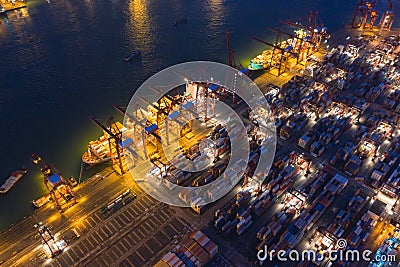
[0,0,398,229]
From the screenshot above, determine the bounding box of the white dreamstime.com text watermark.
[257,238,396,265]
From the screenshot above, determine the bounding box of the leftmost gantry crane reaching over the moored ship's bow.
[90,116,125,174]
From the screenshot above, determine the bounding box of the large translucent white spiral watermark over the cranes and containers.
[123,61,276,207]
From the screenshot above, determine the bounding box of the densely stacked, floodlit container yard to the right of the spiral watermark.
[206,11,400,266]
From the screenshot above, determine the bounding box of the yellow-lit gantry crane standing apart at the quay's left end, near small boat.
[32,154,76,212]
